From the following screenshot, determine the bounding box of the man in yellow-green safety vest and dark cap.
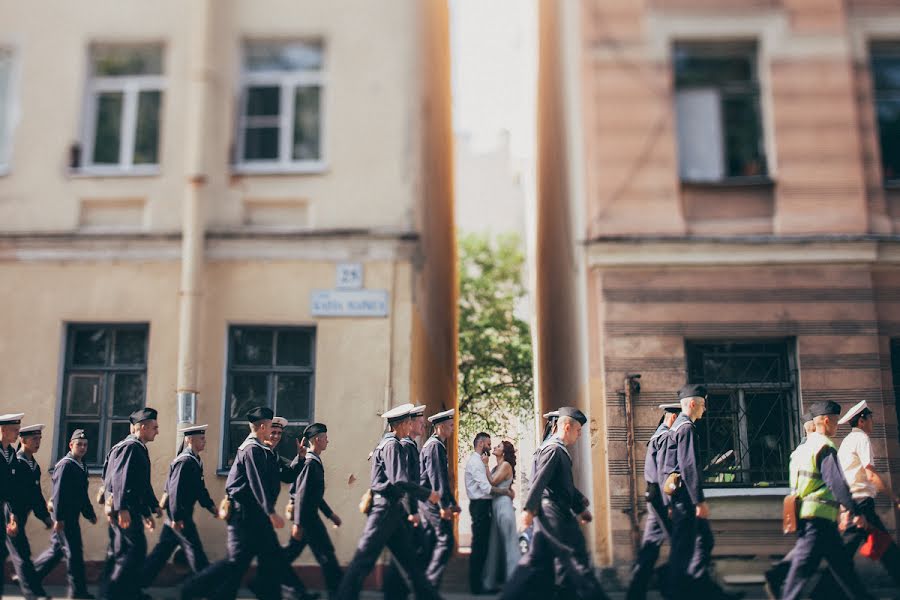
[782,401,872,600]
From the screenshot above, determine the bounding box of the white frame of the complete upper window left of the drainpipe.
[81,72,165,175]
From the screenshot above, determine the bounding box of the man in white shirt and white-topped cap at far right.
[813,400,900,598]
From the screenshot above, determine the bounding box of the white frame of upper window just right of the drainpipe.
[234,49,327,174]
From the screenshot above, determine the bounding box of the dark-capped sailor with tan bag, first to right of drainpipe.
[181,406,316,599]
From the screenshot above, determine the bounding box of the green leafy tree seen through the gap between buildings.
[457,234,534,448]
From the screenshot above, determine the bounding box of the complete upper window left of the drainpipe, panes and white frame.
[81,45,163,173]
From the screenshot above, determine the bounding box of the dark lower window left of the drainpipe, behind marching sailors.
[58,325,148,467]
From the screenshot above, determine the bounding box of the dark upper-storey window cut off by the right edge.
[871,42,900,185]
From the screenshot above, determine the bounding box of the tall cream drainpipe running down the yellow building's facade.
[175,0,215,445]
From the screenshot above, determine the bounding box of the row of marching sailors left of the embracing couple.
[0,404,459,600]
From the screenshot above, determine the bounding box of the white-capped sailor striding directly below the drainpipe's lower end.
[143,425,218,587]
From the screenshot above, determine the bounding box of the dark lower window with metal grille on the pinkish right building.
[687,340,801,487]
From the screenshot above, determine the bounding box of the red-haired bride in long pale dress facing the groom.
[484,440,522,590]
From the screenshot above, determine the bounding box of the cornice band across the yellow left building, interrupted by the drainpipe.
[0,229,420,262]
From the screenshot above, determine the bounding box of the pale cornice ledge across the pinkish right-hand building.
[584,235,900,267]
